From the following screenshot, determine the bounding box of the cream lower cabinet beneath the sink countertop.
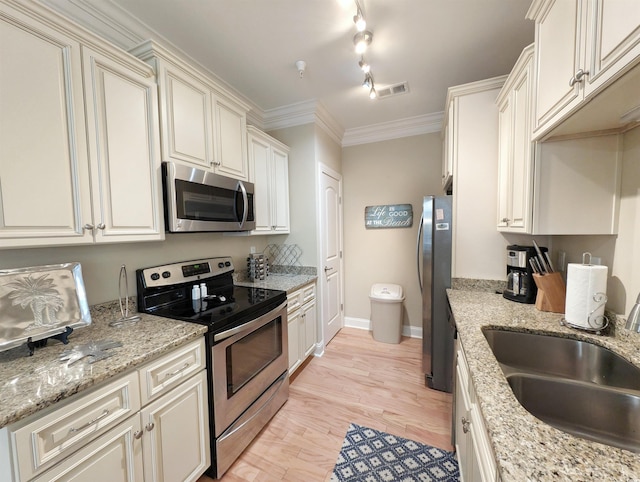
[454,339,500,482]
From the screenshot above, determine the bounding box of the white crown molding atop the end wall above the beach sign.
[342,112,444,147]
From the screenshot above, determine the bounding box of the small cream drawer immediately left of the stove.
[138,337,205,405]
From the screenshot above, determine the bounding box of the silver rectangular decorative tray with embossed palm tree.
[0,263,91,351]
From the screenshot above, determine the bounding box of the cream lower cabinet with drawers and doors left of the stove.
[0,339,210,482]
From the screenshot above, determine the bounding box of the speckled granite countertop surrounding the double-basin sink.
[447,290,640,482]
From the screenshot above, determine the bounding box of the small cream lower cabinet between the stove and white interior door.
[287,282,318,375]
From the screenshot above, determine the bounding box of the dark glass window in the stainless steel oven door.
[226,316,282,398]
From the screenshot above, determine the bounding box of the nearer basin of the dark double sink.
[507,374,640,452]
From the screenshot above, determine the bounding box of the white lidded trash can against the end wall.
[369,283,404,343]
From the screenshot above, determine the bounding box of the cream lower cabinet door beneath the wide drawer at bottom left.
[34,415,144,482]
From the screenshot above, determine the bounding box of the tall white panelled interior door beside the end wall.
[320,165,344,345]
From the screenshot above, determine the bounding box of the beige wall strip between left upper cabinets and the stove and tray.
[0,233,268,305]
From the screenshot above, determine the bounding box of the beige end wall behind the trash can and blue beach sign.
[342,133,442,328]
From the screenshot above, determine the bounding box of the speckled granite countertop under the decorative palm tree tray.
[0,302,207,428]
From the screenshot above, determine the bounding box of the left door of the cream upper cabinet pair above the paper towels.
[534,0,587,137]
